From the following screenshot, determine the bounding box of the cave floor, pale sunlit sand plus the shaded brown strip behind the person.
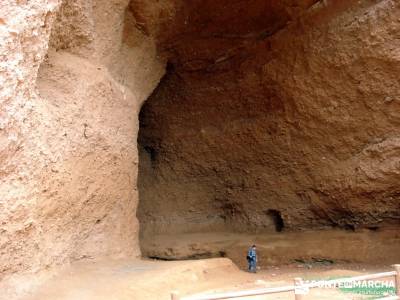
[6,228,400,300]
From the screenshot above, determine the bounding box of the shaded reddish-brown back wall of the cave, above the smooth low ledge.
[139,1,400,238]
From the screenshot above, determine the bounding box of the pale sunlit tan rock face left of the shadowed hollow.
[0,0,164,291]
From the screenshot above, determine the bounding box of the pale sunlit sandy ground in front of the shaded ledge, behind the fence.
[14,258,396,300]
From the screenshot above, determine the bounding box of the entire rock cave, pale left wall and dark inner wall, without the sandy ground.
[0,0,400,296]
